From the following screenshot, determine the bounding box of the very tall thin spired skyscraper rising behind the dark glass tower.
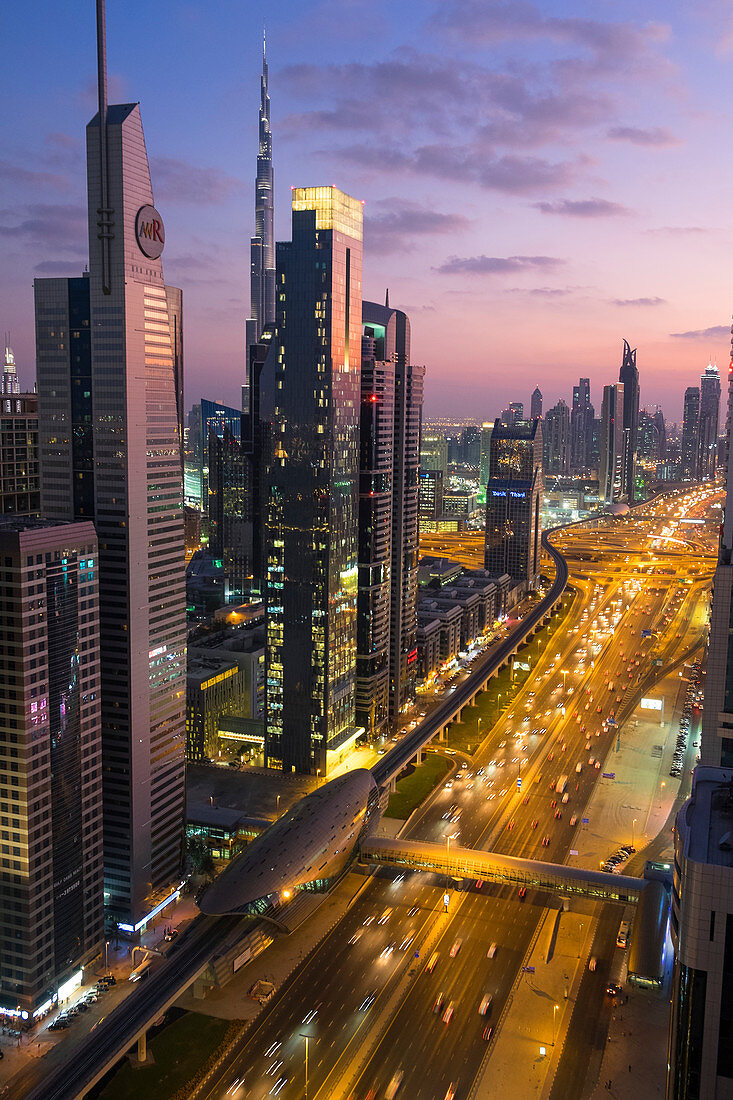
[247,35,275,358]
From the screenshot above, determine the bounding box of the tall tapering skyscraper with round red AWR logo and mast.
[35,2,186,933]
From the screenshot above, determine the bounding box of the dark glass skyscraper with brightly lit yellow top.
[260,187,363,778]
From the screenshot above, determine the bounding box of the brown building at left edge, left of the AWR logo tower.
[0,393,41,516]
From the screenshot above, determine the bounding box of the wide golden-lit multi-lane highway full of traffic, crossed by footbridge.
[202,490,721,1100]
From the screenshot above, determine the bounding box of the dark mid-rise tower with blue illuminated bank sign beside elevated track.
[484,420,543,586]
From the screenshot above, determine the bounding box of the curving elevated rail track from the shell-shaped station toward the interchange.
[372,520,572,787]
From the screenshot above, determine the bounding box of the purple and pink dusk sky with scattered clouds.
[0,0,733,421]
